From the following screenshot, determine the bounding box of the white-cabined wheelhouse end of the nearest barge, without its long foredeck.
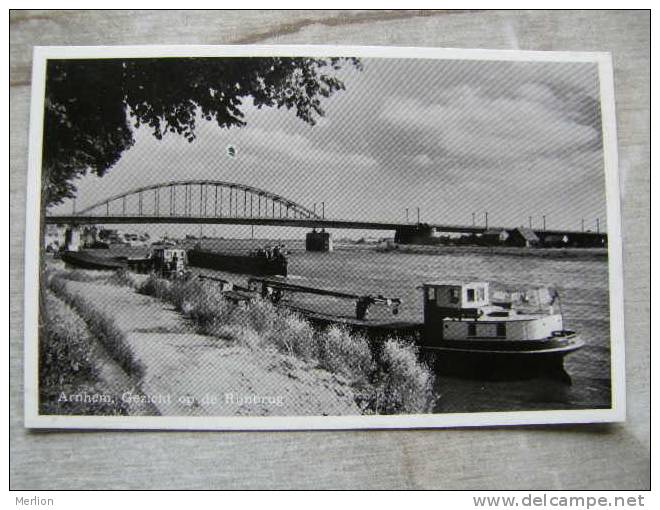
[421,282,584,379]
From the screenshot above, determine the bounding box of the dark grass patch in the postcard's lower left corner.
[39,292,128,416]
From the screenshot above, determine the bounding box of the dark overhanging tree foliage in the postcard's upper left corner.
[43,57,361,205]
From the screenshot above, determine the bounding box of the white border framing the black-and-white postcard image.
[24,45,626,430]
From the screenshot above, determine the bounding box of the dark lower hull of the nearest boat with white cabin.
[422,333,584,382]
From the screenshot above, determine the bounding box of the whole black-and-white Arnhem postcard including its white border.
[25,46,625,429]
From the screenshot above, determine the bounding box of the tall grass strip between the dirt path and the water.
[137,276,435,414]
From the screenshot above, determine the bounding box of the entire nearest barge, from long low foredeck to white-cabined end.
[248,278,584,382]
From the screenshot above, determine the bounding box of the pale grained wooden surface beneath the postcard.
[10,11,650,489]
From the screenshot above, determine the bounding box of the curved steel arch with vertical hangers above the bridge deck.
[74,179,321,219]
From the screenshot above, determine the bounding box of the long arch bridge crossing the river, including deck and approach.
[45,179,607,246]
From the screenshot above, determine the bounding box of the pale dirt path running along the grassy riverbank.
[67,281,360,416]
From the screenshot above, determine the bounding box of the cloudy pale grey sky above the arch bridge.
[51,58,607,240]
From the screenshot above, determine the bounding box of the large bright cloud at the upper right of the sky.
[379,84,600,165]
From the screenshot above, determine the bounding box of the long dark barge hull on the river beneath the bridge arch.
[188,250,287,276]
